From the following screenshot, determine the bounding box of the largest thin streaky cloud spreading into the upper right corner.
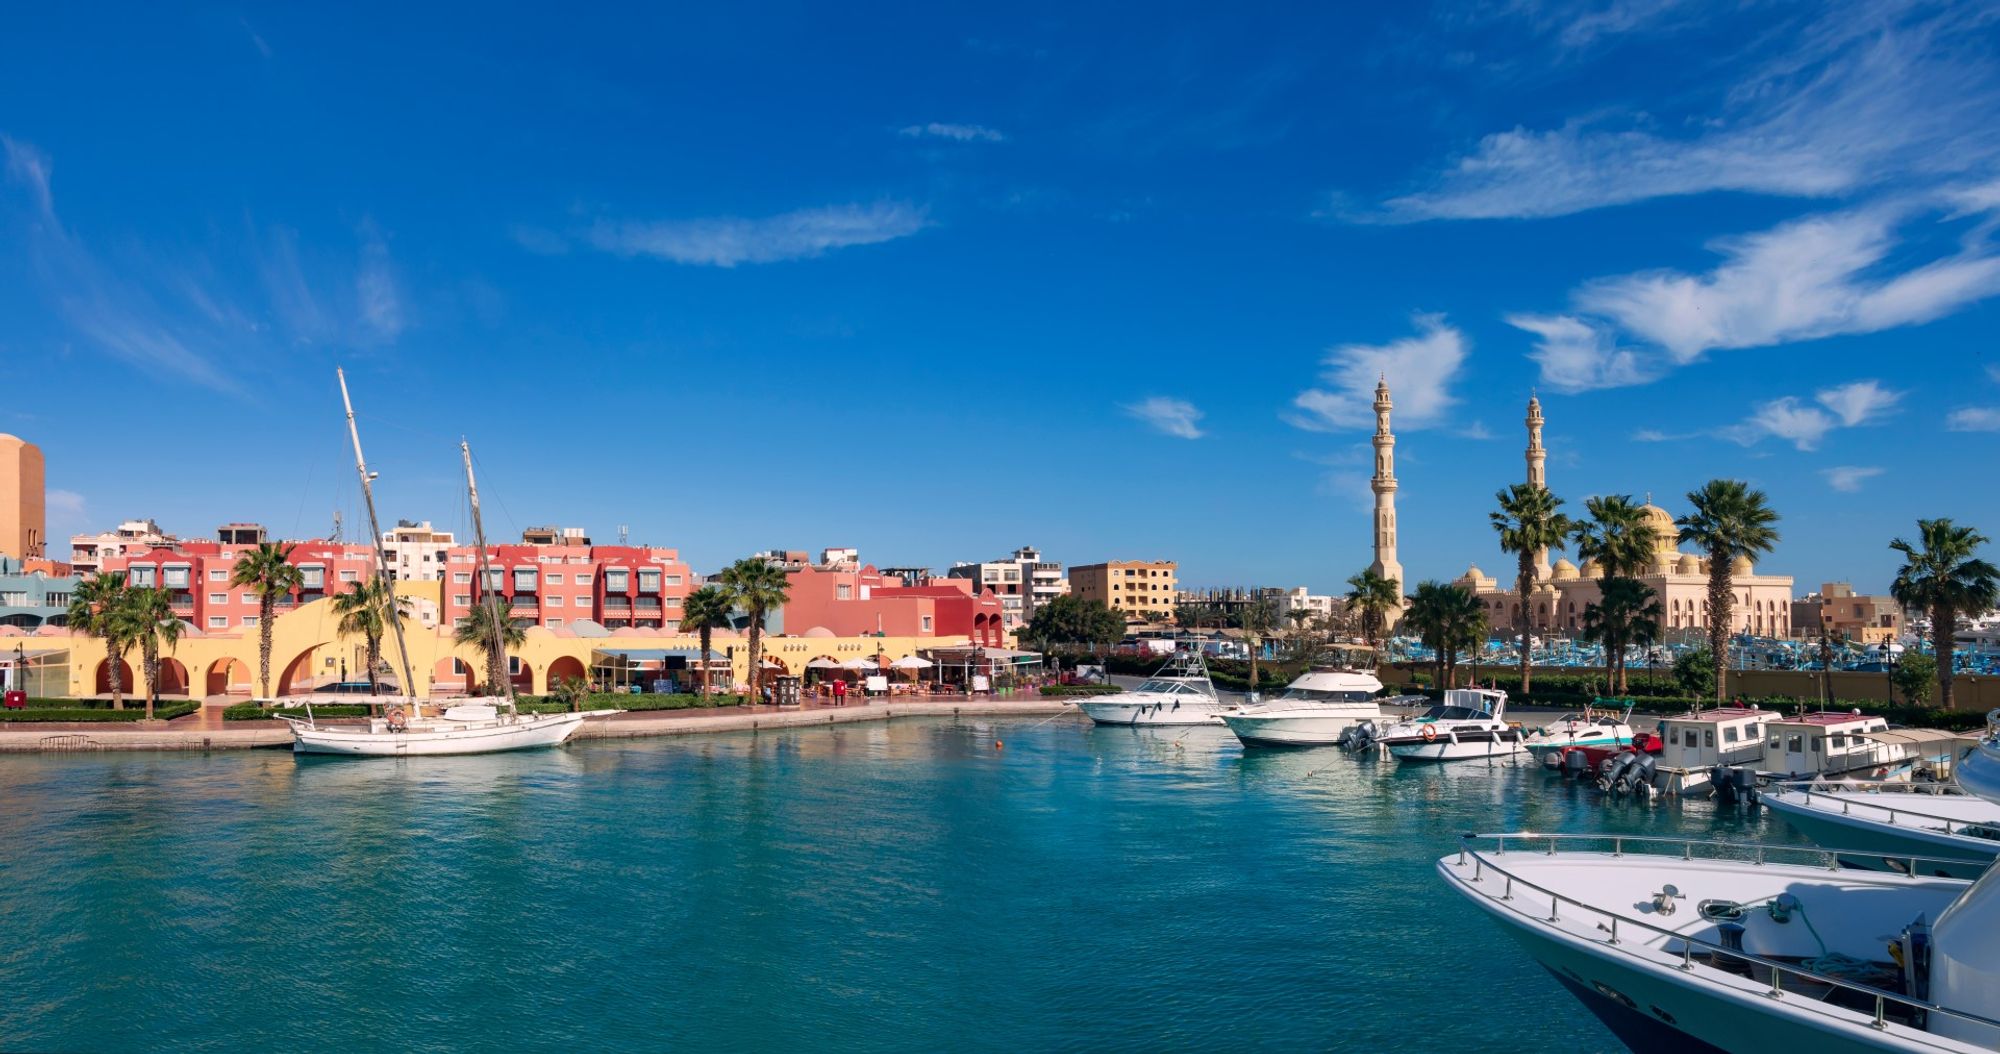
[1350,2,2000,222]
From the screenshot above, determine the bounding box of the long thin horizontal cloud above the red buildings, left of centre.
[590,202,930,268]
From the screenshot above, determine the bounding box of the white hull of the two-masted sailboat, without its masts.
[282,698,618,758]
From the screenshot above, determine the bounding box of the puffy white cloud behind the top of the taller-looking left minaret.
[1286,314,1472,432]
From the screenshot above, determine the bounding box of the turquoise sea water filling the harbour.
[0,718,1792,1052]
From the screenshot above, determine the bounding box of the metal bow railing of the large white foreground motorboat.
[1452,832,2000,1030]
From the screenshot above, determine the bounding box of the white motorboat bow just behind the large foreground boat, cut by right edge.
[1758,780,2000,878]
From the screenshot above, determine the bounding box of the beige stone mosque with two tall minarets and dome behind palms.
[1372,382,1792,638]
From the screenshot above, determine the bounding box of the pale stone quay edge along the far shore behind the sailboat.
[0,692,1076,754]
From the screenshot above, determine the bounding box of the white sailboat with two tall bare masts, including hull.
[284,370,616,758]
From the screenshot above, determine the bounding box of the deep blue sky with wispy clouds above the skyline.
[0,0,2000,592]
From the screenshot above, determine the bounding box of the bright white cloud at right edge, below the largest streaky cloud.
[1572,208,2000,364]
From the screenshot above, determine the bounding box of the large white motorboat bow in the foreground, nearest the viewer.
[1438,712,2000,1052]
